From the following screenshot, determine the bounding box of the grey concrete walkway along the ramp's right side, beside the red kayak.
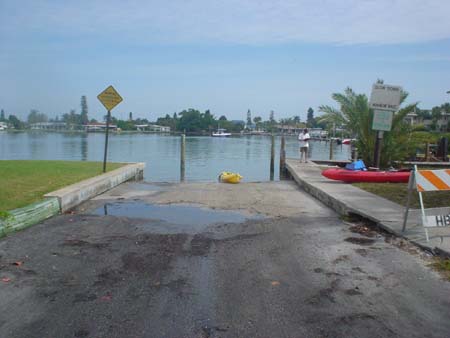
[286,159,450,256]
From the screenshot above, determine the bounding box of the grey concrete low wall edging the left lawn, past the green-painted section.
[44,162,145,212]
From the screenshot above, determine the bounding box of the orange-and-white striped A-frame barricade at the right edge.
[402,166,450,241]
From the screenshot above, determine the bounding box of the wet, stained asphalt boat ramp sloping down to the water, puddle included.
[0,182,450,338]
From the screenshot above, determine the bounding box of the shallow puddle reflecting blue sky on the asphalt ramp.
[93,201,264,227]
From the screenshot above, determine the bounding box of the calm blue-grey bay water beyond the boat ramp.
[0,131,350,182]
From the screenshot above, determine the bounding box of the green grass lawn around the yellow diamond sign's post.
[0,160,124,211]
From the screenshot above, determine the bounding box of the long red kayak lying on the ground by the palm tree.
[322,168,410,183]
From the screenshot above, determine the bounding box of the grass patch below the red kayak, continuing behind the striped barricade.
[353,183,450,208]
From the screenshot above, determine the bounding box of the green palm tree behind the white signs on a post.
[318,88,417,166]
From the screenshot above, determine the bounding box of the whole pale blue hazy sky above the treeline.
[0,0,450,120]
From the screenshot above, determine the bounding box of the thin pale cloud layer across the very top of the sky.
[0,0,450,45]
